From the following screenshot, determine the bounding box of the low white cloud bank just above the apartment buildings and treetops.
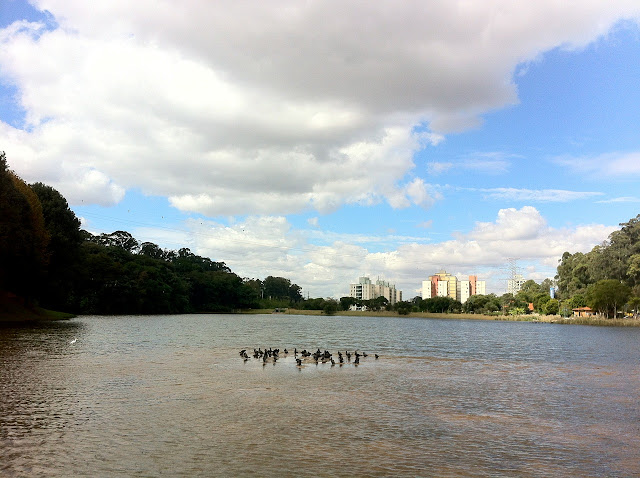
[132,206,619,298]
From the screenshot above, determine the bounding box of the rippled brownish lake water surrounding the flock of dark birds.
[0,315,640,477]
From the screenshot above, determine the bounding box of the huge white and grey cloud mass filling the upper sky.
[0,0,640,215]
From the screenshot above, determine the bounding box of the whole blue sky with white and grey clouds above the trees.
[0,0,640,299]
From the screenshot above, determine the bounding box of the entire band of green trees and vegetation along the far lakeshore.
[0,153,640,325]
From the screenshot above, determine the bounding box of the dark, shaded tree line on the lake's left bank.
[0,152,302,314]
